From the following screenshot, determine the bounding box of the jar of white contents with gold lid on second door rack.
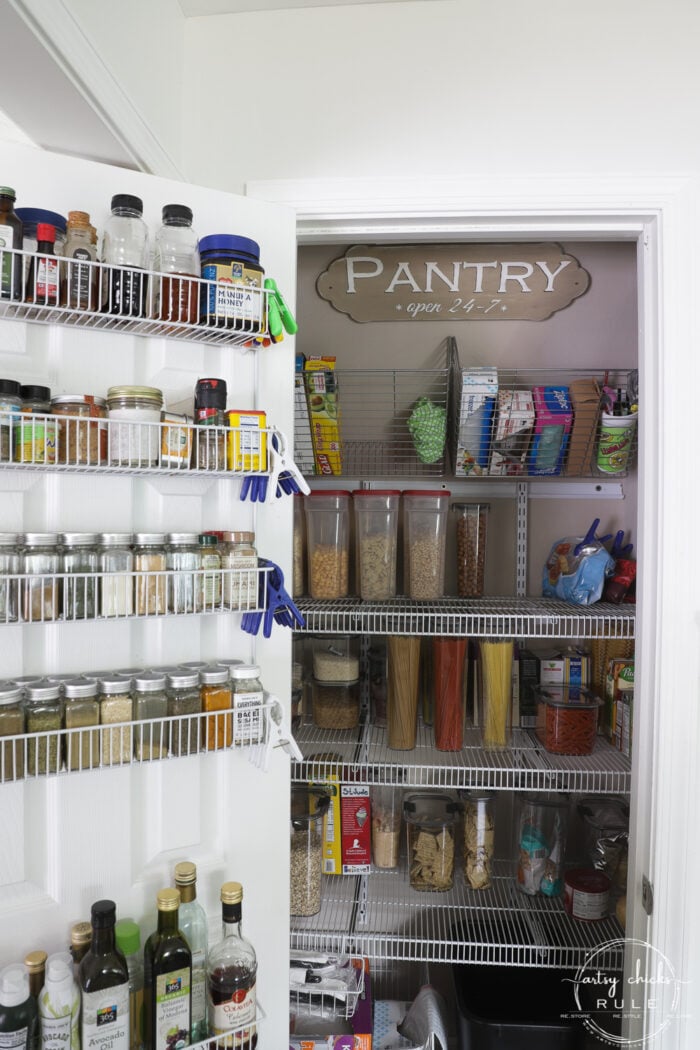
[107,386,163,467]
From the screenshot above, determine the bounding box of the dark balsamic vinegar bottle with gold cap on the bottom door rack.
[144,889,192,1050]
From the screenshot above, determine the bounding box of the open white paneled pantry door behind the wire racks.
[0,141,296,1047]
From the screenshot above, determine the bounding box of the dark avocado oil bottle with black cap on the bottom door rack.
[79,901,129,1050]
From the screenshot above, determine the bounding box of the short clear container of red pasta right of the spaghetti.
[532,686,602,755]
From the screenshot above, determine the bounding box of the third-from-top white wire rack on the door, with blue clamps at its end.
[0,566,272,627]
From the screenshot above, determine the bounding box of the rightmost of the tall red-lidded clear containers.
[403,489,450,599]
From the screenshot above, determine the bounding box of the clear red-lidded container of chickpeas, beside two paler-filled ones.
[305,489,351,599]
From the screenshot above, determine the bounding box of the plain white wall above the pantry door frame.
[184,0,700,190]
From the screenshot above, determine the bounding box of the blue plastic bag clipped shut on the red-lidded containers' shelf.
[542,518,615,605]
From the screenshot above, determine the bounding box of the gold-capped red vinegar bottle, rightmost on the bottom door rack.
[207,882,257,1050]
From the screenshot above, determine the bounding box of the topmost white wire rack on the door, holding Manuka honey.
[0,249,269,347]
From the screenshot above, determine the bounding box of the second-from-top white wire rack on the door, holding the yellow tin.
[0,412,277,478]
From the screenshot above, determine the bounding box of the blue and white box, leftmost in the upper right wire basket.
[454,365,499,477]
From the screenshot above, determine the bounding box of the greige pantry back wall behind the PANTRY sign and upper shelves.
[297,242,637,596]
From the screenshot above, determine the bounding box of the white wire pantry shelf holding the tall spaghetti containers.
[292,725,632,795]
